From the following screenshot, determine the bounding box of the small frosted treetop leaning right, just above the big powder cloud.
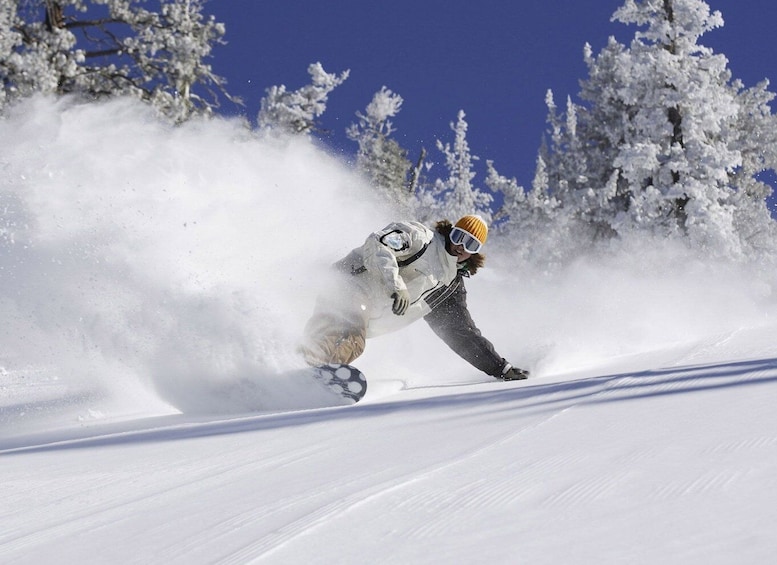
[258,63,350,134]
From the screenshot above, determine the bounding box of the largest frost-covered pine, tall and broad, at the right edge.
[548,0,777,256]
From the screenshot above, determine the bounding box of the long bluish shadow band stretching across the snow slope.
[0,358,777,455]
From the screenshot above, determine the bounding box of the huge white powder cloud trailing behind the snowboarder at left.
[0,94,390,416]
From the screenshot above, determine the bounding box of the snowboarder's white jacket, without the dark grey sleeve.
[338,222,457,337]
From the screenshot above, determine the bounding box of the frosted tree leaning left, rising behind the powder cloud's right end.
[347,86,412,210]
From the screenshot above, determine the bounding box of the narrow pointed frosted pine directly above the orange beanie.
[419,110,493,223]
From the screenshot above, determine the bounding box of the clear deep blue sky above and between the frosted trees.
[206,0,777,193]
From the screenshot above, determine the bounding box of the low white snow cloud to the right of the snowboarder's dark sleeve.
[470,236,775,376]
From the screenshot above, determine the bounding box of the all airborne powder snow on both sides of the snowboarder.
[0,97,772,412]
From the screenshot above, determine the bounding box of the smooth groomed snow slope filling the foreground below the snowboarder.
[0,327,777,564]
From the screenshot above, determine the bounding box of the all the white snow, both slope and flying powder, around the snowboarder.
[0,100,777,565]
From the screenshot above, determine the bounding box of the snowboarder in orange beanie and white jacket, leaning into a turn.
[301,215,529,381]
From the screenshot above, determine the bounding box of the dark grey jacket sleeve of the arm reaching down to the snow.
[424,274,506,377]
